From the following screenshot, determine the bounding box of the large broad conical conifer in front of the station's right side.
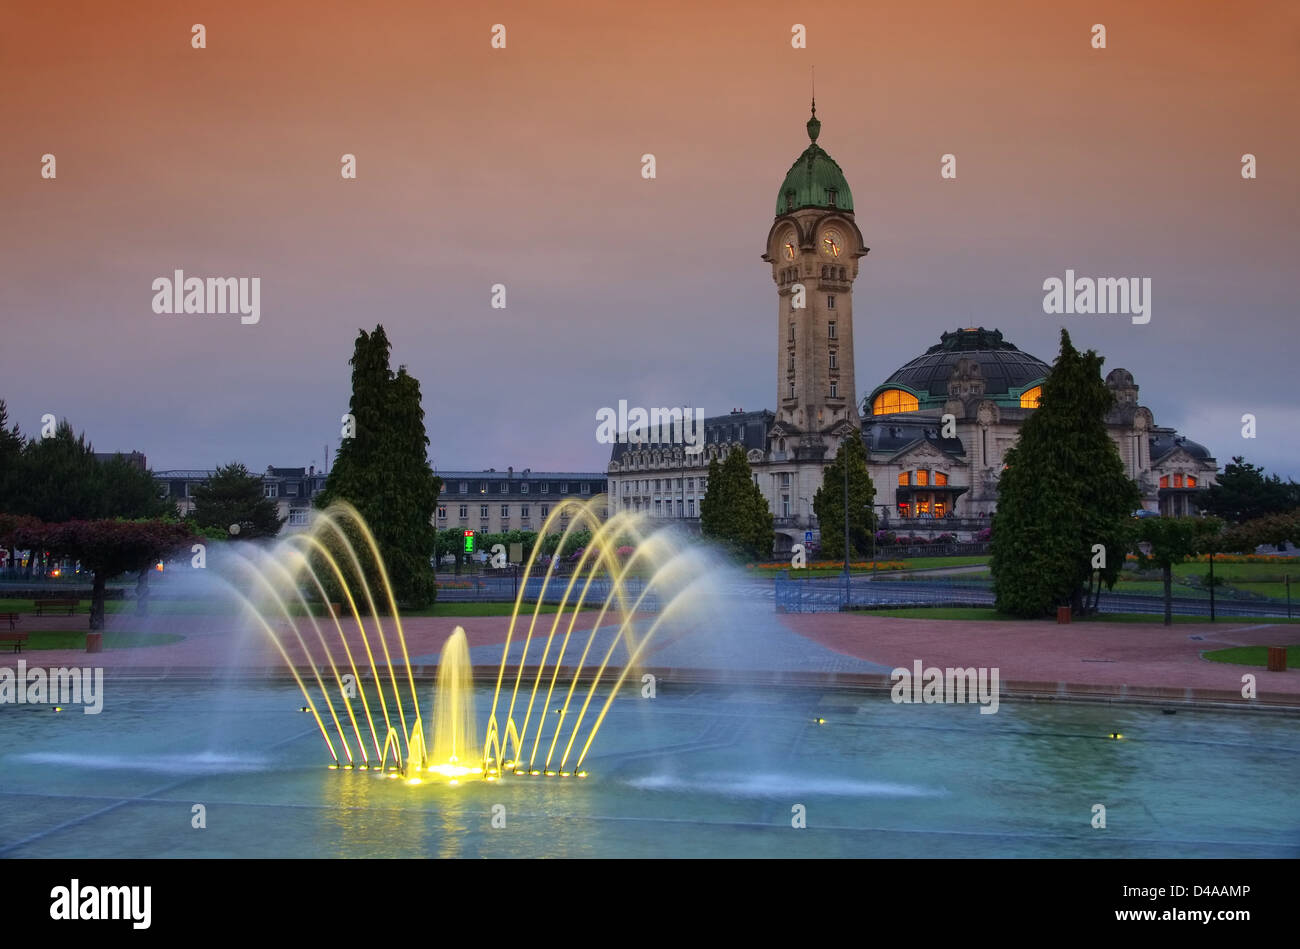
[989,330,1141,616]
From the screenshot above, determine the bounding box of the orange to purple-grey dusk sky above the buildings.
[0,0,1300,478]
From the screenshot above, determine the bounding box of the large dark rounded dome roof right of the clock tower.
[872,326,1052,403]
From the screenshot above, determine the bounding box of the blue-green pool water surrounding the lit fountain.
[0,681,1300,857]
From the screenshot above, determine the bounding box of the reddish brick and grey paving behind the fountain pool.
[0,603,1300,697]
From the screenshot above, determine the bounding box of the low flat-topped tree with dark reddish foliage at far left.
[12,520,194,629]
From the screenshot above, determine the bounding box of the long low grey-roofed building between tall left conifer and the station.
[433,467,606,534]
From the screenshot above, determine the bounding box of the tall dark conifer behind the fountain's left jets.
[316,325,442,608]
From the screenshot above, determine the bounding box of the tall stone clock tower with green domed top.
[763,100,868,462]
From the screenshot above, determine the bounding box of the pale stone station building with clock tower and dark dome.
[606,107,1217,551]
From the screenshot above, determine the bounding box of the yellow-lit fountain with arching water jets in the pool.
[230,497,706,784]
